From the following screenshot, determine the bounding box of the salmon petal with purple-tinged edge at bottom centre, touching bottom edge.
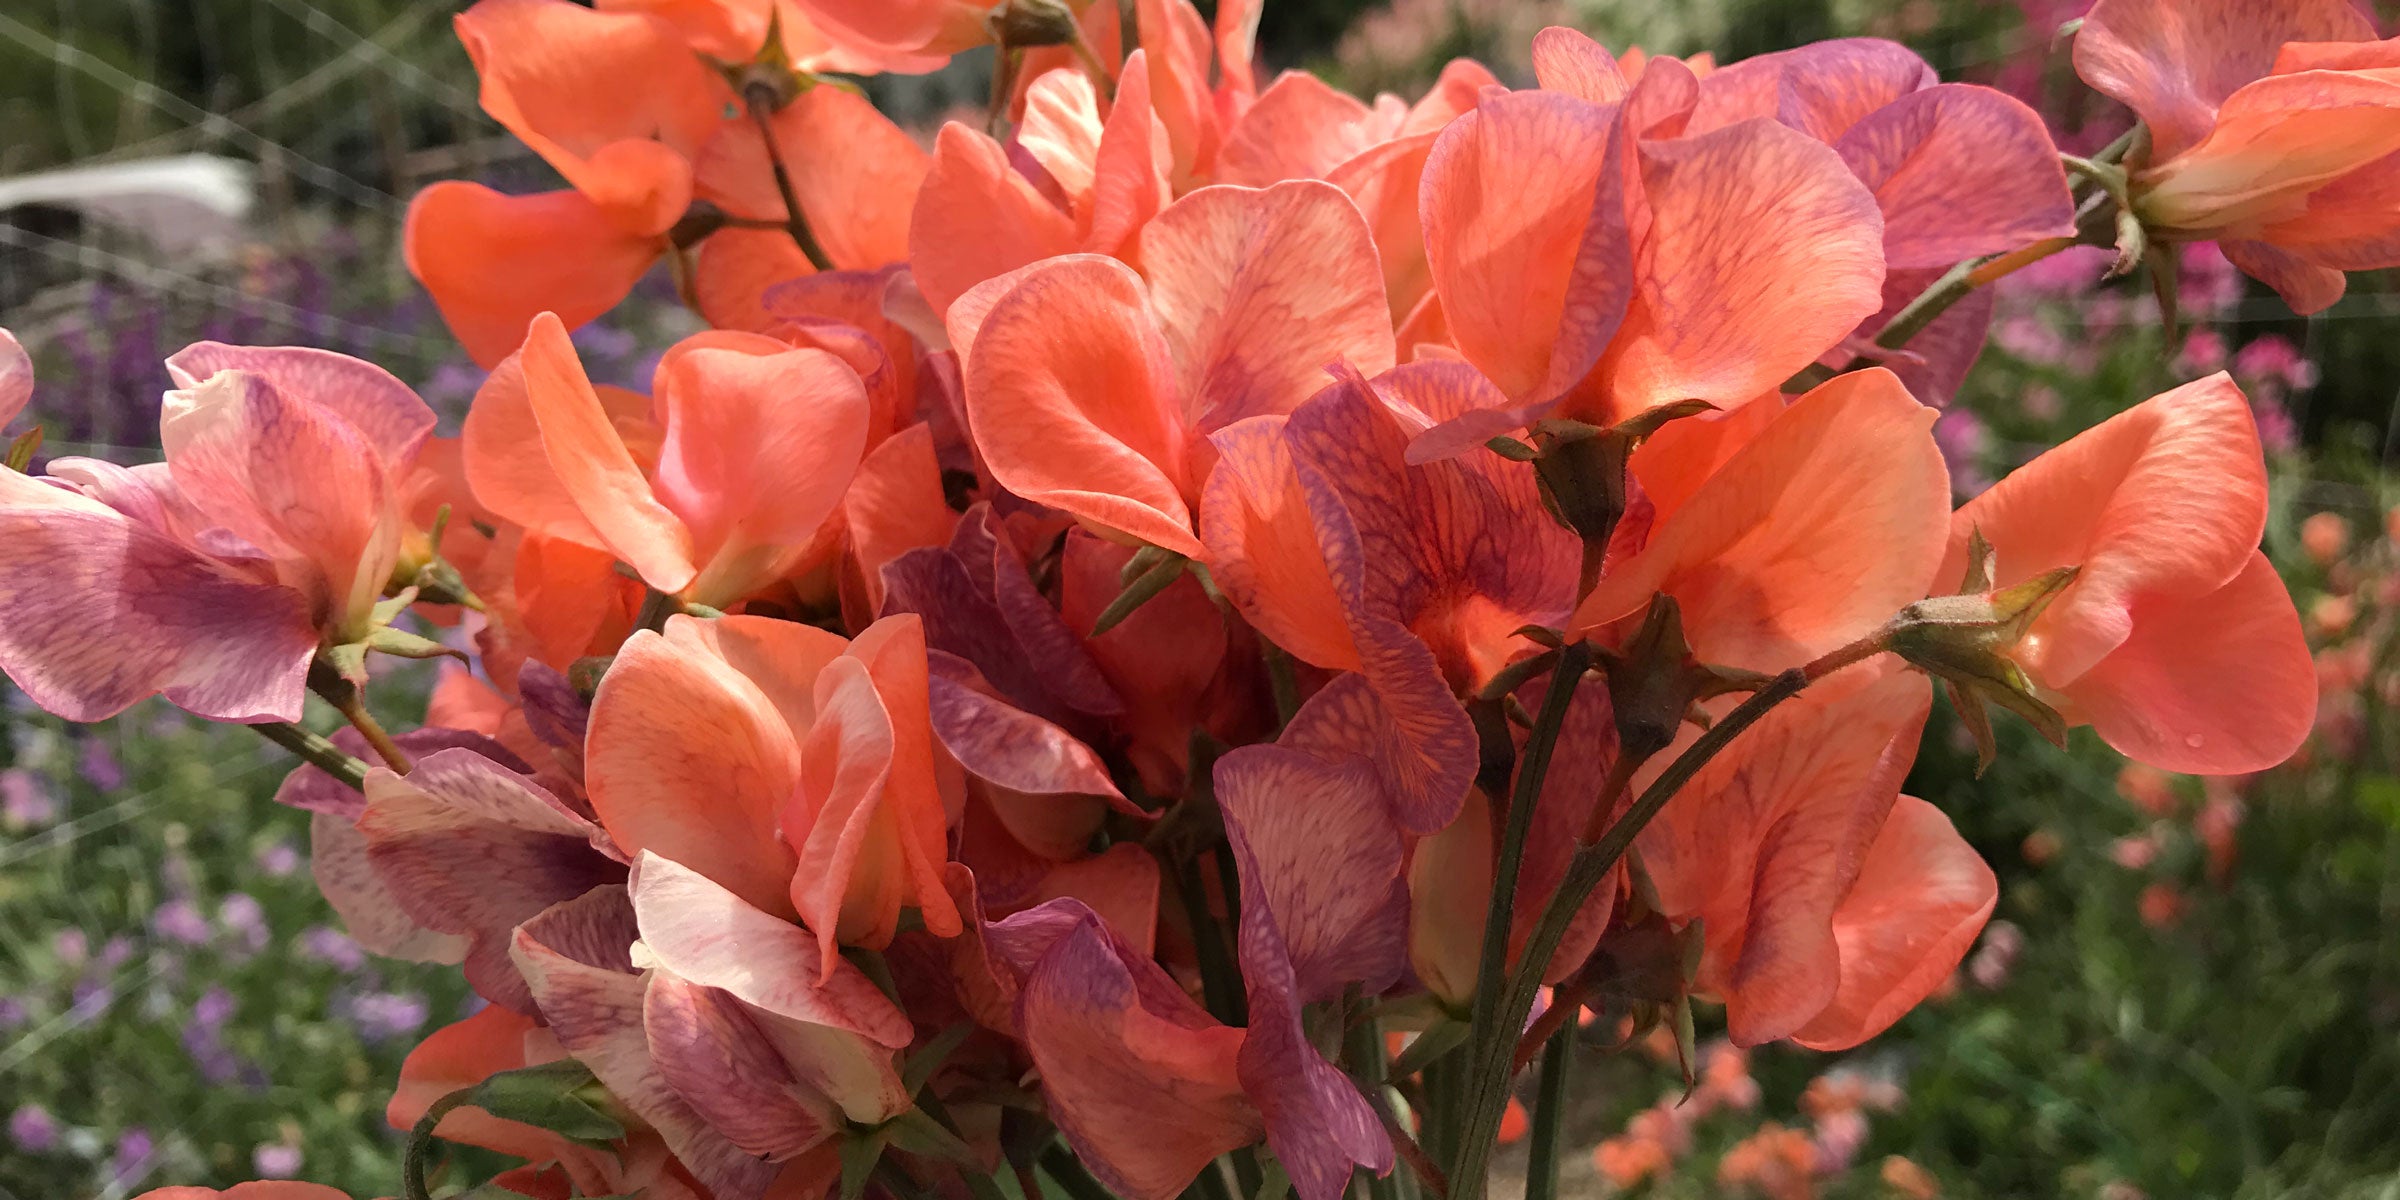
[1018,900,1262,1200]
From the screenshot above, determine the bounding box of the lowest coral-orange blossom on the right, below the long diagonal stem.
[1637,667,1999,1049]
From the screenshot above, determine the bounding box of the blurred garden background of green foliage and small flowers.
[0,0,2400,1200]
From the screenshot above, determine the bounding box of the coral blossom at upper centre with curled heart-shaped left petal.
[948,182,1392,557]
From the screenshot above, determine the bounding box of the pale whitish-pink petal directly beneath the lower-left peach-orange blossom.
[631,852,914,1049]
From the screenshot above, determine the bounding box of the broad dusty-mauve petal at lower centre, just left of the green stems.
[1217,739,1409,1003]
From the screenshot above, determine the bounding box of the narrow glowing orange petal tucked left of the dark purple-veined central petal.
[1200,415,1358,670]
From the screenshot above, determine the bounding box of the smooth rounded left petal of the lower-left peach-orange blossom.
[583,622,823,914]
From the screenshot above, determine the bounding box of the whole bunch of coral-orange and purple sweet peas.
[0,0,2352,1200]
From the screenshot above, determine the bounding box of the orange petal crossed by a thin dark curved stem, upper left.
[696,86,931,271]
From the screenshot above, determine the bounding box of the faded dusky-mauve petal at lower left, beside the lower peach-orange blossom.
[358,749,624,1013]
